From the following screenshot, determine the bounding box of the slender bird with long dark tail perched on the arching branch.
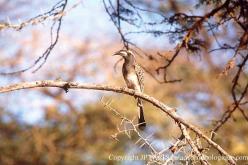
[114,50,146,130]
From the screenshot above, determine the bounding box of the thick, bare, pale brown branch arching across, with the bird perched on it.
[0,80,236,164]
